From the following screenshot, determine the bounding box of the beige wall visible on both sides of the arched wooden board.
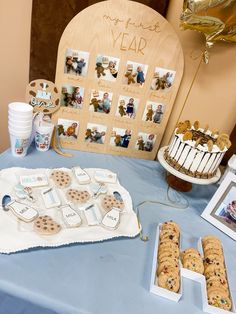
[0,0,236,151]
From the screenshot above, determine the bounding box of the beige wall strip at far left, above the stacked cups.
[0,0,32,152]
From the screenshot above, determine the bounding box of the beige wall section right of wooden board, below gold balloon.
[162,0,236,145]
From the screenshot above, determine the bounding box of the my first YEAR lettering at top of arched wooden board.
[103,15,160,55]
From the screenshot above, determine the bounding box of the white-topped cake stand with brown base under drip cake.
[158,146,221,192]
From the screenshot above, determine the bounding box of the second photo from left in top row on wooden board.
[94,54,120,82]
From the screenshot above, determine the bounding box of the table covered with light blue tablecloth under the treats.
[0,149,236,314]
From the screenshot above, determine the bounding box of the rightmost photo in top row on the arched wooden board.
[151,67,176,91]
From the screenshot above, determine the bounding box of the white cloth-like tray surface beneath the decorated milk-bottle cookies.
[0,168,140,253]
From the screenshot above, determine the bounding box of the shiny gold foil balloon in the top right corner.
[180,0,236,63]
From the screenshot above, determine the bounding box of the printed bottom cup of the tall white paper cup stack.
[10,133,30,157]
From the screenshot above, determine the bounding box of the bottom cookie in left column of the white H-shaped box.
[158,269,180,292]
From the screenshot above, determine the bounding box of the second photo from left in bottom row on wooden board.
[84,123,107,144]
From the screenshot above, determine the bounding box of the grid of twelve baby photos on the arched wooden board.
[58,48,175,152]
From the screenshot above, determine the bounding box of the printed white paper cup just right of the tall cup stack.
[34,122,54,152]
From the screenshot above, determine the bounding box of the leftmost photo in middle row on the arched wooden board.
[61,84,84,109]
